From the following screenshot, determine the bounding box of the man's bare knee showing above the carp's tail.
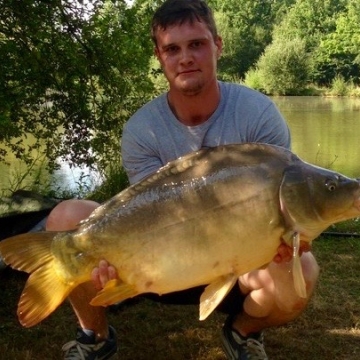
[46,199,99,231]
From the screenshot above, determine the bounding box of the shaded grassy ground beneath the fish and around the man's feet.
[0,236,360,360]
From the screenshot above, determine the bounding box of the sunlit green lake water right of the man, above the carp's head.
[273,96,360,177]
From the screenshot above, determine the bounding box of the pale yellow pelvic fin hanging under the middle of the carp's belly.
[200,274,238,320]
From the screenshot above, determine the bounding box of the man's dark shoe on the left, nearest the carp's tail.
[62,326,117,360]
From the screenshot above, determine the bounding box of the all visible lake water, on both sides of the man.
[0,96,360,195]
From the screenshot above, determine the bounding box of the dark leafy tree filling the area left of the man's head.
[0,0,152,172]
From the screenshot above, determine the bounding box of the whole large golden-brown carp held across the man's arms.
[0,144,360,327]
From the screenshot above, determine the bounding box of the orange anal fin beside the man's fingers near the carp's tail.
[90,279,139,306]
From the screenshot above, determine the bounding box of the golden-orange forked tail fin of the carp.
[0,232,76,327]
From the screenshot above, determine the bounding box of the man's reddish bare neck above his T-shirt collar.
[168,83,220,126]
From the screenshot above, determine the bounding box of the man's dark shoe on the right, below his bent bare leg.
[221,316,268,360]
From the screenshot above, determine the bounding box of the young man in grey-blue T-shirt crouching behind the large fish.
[47,0,318,359]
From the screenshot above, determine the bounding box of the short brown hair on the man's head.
[151,0,218,45]
